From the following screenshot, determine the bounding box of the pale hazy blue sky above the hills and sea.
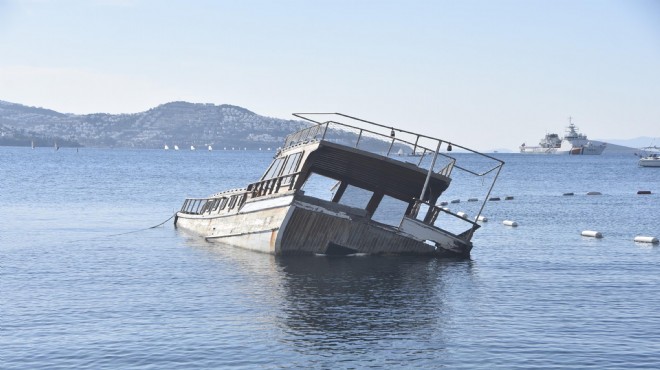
[0,0,660,150]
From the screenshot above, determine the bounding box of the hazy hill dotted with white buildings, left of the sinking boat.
[0,101,308,149]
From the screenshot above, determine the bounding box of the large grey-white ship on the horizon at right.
[520,117,607,155]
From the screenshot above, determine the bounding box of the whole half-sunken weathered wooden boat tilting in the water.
[174,113,504,258]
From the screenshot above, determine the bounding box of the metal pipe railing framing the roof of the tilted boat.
[292,113,504,224]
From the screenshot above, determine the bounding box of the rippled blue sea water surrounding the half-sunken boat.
[0,147,660,369]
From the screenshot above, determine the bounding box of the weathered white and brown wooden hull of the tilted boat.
[175,195,472,258]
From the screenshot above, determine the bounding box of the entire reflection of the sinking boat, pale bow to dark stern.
[187,233,473,349]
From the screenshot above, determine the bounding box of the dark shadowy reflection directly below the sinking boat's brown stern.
[277,256,470,341]
